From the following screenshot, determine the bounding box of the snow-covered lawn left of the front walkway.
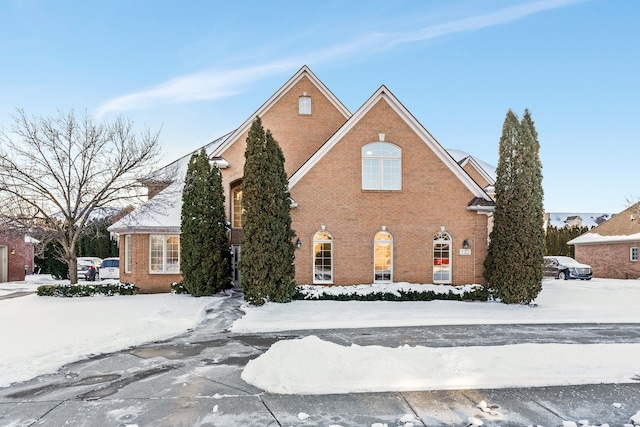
[0,275,223,387]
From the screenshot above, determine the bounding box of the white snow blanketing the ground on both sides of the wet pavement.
[0,276,640,400]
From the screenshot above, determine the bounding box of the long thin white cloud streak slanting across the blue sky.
[98,0,584,115]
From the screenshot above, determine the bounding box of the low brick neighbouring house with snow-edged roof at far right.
[568,203,640,279]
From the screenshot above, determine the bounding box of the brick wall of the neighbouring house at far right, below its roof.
[575,241,640,279]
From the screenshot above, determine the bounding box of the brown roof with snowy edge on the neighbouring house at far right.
[568,202,640,245]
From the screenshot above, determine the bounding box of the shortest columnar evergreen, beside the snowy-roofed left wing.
[180,150,231,296]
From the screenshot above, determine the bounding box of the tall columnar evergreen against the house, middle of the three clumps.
[238,118,295,305]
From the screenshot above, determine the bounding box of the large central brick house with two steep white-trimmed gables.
[109,67,494,292]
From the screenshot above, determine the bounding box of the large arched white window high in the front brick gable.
[362,142,402,190]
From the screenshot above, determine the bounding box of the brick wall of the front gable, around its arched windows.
[291,101,487,284]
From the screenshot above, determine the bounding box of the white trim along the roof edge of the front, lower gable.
[289,85,493,209]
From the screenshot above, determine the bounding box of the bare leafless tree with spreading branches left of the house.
[0,109,160,283]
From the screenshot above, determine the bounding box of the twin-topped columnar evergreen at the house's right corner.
[484,110,544,304]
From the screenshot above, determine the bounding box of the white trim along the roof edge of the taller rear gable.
[211,65,351,157]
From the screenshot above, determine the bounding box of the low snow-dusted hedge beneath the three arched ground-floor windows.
[293,286,489,301]
